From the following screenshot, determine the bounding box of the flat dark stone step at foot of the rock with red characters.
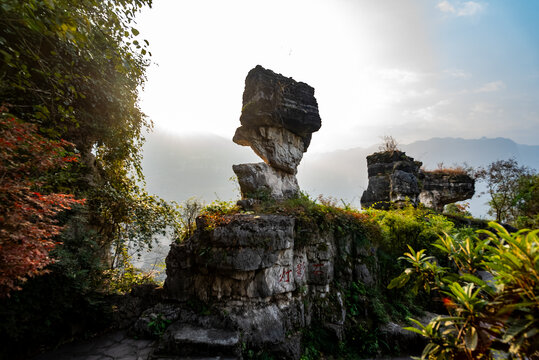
[152,323,241,360]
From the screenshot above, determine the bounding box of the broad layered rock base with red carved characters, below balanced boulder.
[158,214,377,359]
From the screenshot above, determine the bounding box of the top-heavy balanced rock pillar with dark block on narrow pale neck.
[233,65,322,199]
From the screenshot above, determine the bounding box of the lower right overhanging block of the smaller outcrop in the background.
[419,171,475,211]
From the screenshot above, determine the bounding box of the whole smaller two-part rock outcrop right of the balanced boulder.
[361,151,475,211]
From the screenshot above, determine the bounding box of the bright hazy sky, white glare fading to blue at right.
[138,0,539,151]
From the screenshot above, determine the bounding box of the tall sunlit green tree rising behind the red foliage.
[0,0,181,262]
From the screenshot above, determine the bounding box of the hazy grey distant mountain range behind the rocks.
[142,131,539,216]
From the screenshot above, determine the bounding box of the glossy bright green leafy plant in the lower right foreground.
[388,222,539,359]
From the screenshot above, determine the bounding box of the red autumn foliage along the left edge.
[0,111,84,297]
